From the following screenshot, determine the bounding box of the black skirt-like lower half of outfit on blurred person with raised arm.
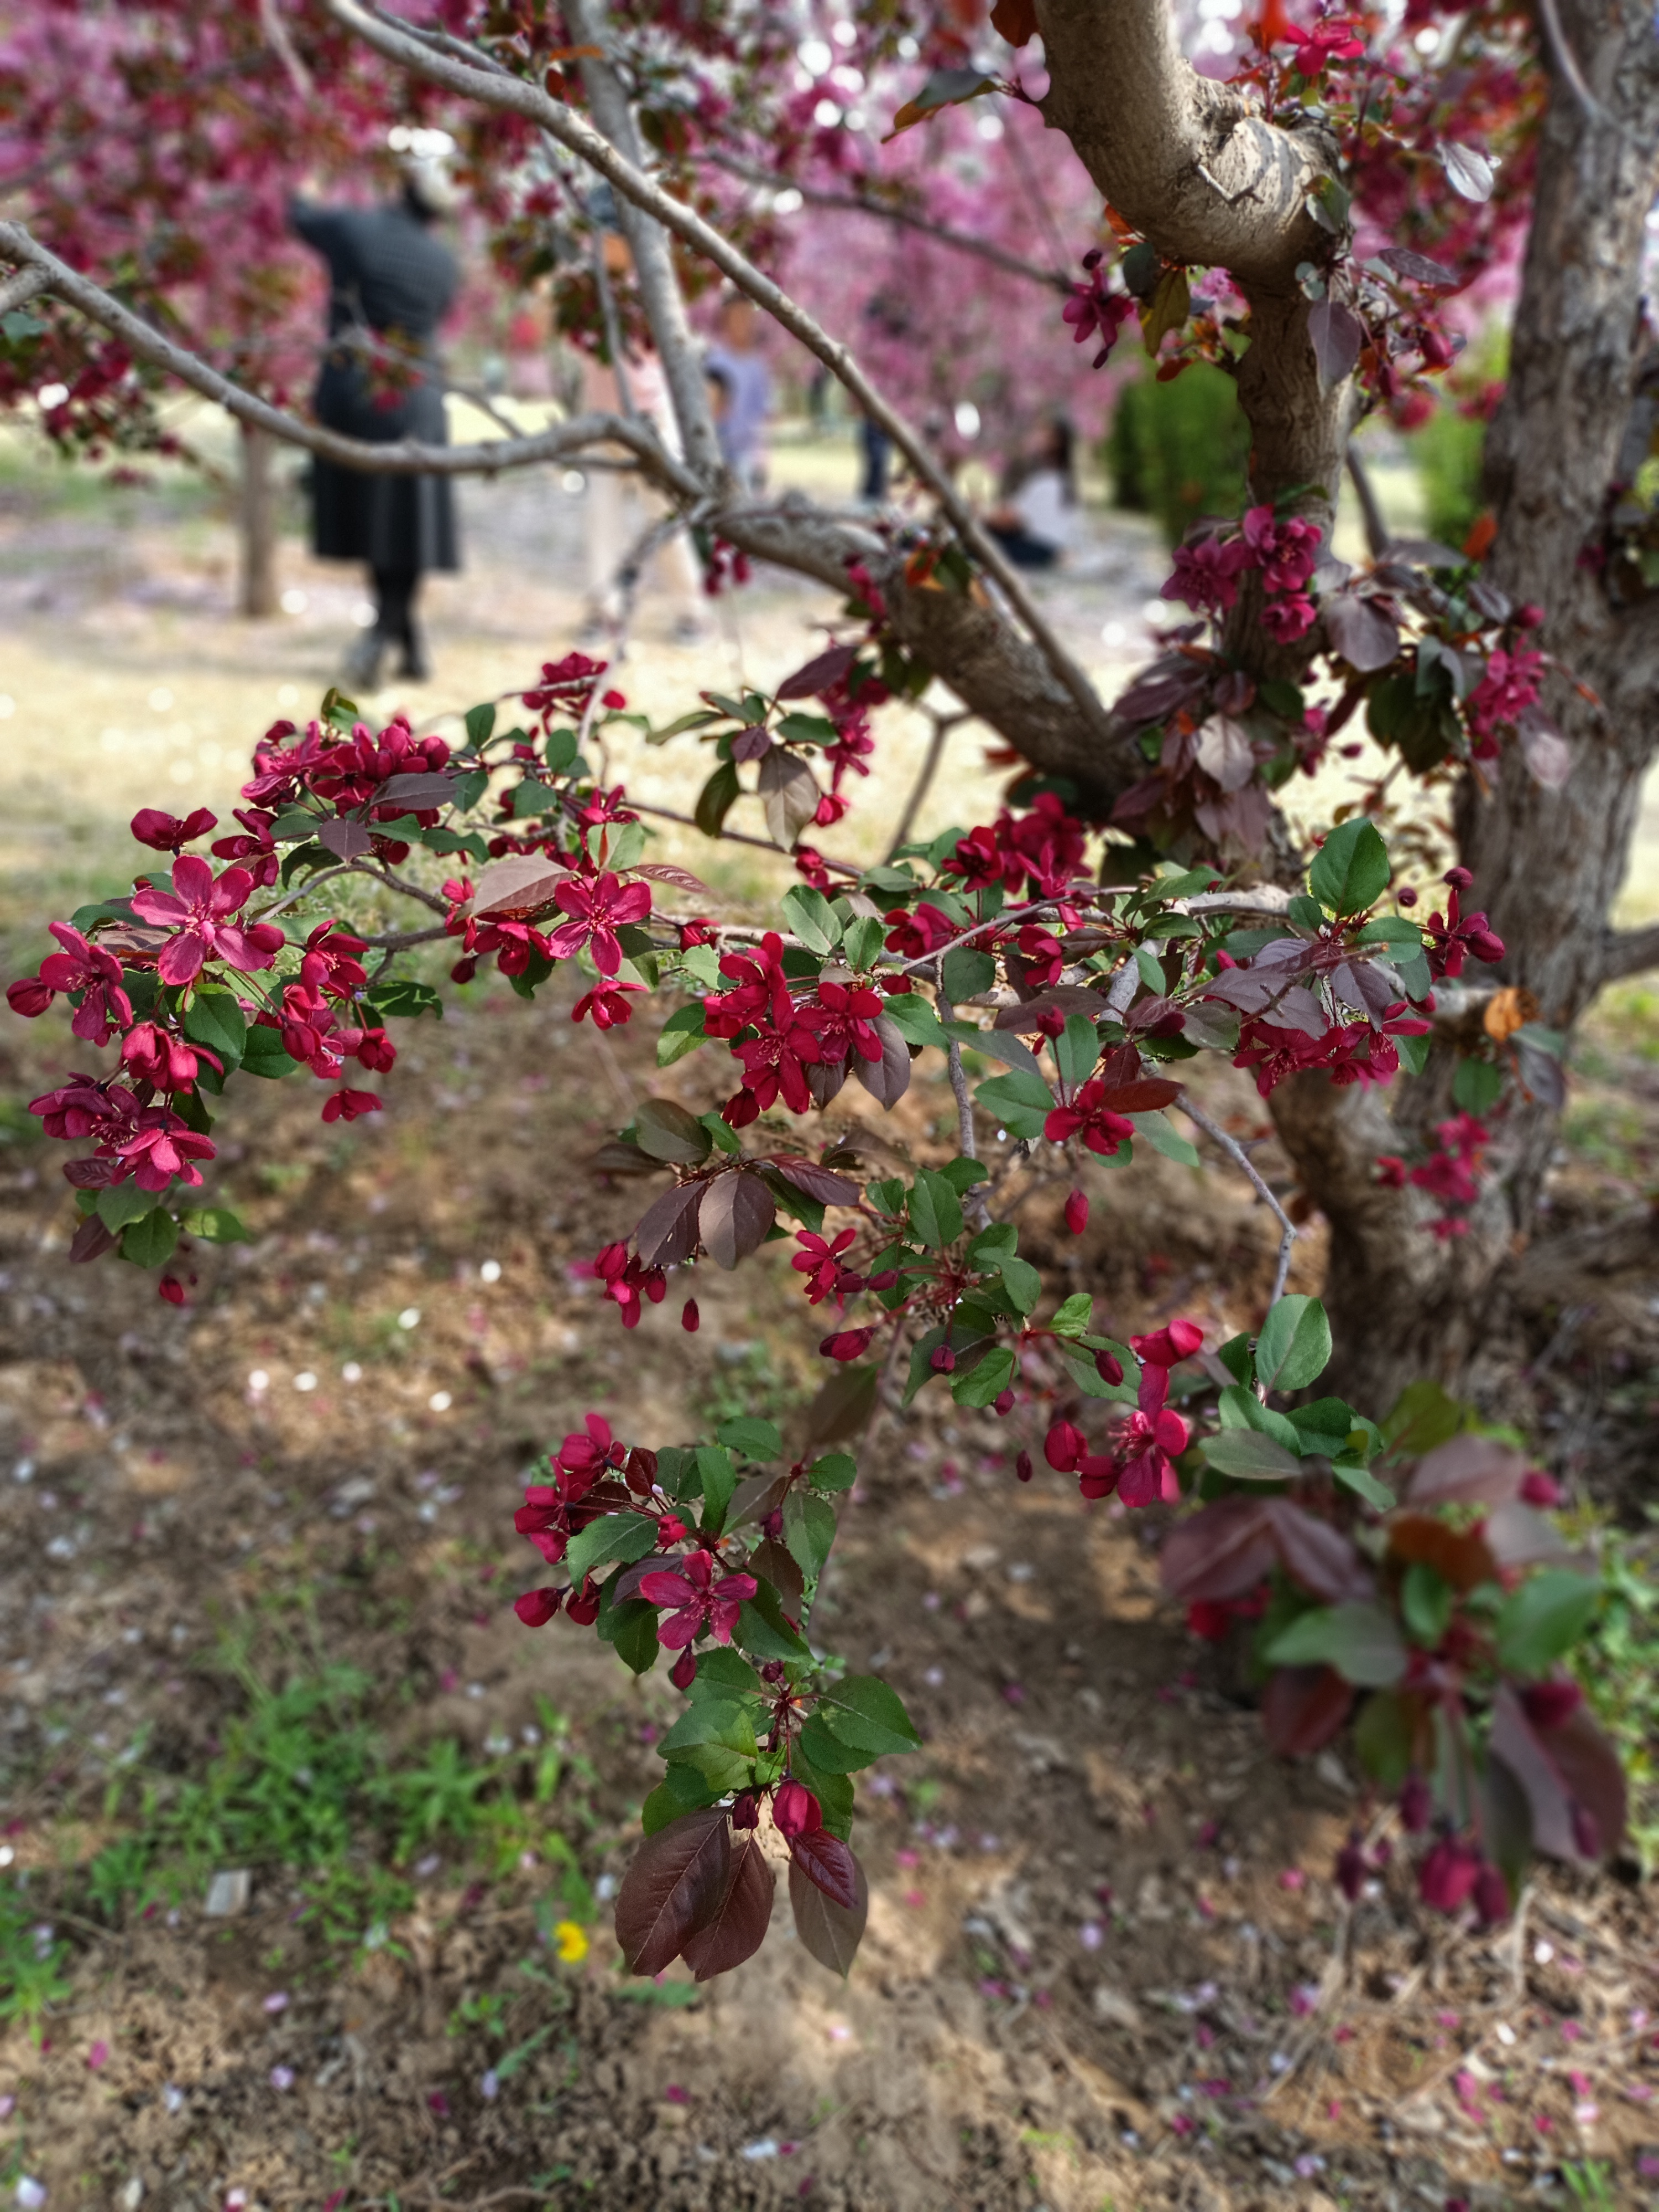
[312,354,460,573]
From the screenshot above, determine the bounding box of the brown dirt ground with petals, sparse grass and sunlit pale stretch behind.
[0,431,1659,2212]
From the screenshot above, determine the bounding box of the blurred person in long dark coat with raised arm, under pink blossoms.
[288,159,460,690]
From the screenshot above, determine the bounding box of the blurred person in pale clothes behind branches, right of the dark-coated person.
[582,184,708,646]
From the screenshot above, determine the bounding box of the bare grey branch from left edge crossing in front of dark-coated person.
[0,223,703,498]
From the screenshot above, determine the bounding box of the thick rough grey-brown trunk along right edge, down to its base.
[1272,0,1659,1411]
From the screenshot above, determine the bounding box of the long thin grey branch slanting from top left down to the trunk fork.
[323,0,1115,743]
